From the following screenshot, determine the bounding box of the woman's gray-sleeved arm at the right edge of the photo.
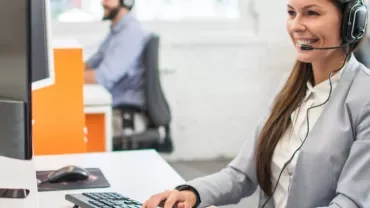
[320,103,370,208]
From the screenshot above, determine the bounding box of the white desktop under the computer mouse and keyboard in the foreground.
[34,150,184,208]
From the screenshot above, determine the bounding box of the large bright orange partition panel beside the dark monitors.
[32,48,86,155]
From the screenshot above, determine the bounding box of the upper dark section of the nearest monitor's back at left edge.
[0,1,30,101]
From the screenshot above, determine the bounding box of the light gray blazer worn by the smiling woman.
[187,55,370,208]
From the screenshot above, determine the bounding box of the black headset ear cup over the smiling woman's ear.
[341,0,368,43]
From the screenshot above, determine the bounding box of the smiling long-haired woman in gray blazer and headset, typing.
[143,0,370,208]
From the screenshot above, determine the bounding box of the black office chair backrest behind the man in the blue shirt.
[142,34,171,127]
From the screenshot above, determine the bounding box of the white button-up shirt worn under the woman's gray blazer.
[271,70,343,208]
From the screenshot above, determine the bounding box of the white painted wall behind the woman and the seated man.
[53,0,294,160]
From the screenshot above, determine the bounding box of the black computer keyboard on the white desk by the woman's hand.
[65,192,142,208]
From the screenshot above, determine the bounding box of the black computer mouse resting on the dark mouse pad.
[48,165,89,183]
